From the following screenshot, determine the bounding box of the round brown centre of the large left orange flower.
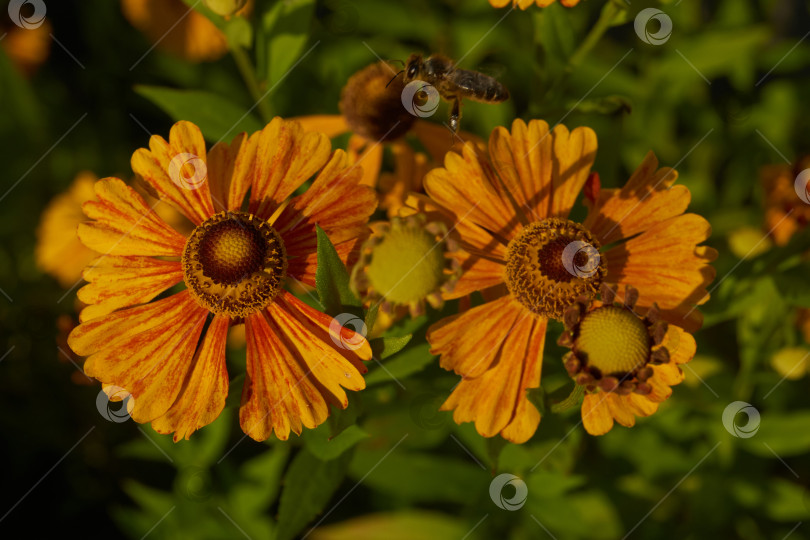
[182,211,287,318]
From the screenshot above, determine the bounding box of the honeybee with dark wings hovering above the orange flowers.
[395,54,509,133]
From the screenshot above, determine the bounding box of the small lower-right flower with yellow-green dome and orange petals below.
[559,285,696,435]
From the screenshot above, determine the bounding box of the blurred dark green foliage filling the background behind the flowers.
[0,0,810,540]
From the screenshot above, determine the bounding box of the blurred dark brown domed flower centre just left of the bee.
[340,62,416,142]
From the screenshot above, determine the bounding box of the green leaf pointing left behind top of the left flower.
[135,85,262,141]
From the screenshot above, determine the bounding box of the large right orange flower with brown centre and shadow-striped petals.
[416,120,716,442]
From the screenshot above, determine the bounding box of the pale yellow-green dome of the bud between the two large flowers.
[366,218,447,304]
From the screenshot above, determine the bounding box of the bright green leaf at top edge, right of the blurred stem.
[257,0,315,87]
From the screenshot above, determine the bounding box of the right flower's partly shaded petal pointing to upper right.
[583,152,691,245]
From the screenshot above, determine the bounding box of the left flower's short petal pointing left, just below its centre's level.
[77,255,183,322]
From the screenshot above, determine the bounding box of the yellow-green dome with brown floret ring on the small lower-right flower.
[558,285,670,395]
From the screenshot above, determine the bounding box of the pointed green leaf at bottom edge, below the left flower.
[276,449,351,540]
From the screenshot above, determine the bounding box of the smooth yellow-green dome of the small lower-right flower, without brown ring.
[574,306,652,376]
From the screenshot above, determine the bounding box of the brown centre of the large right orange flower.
[506,218,606,320]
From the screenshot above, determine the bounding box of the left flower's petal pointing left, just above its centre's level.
[79,178,186,257]
